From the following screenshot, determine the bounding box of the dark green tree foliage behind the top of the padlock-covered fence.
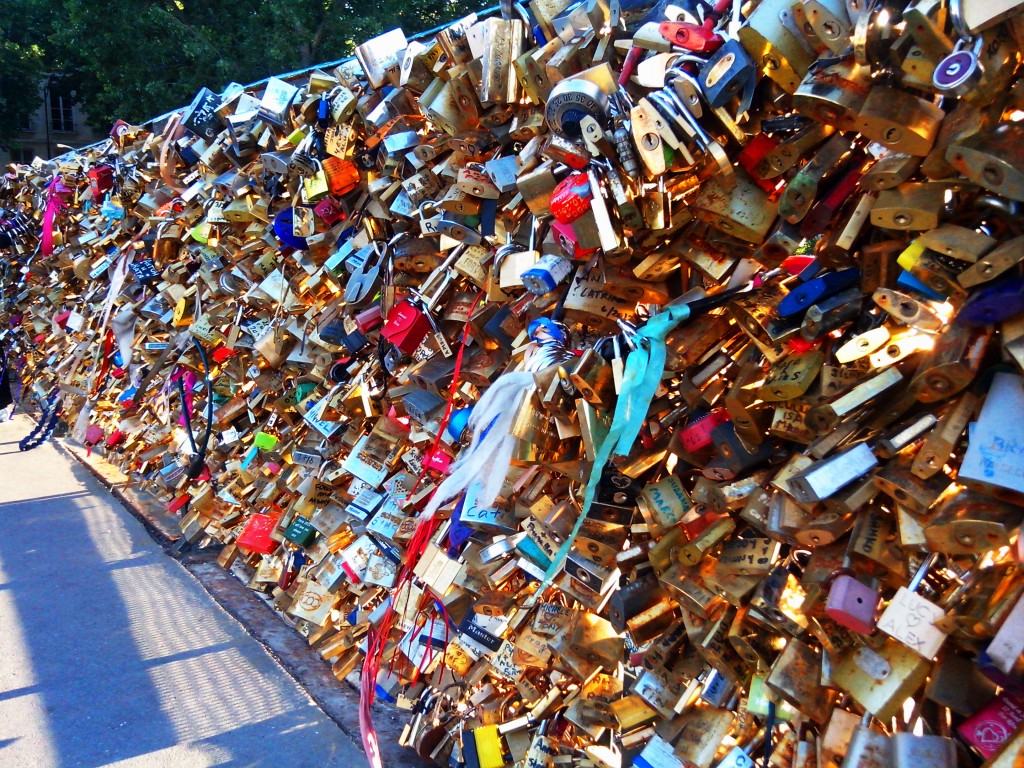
[0,0,486,145]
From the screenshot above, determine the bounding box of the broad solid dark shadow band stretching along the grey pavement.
[0,492,177,768]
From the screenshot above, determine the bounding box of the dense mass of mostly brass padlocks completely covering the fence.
[18,0,1024,768]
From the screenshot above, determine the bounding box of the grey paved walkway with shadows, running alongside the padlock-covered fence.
[0,416,366,768]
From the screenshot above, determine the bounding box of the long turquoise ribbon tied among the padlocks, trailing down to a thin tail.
[534,304,690,597]
